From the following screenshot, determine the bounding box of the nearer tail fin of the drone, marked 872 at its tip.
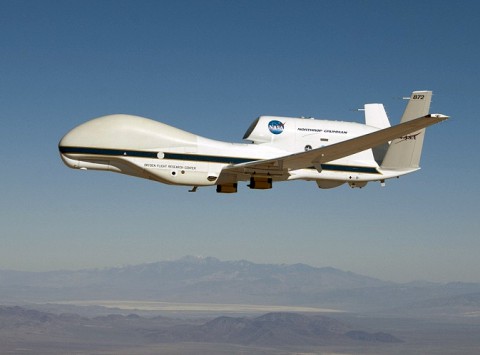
[382,91,432,170]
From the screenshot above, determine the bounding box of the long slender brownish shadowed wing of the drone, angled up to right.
[222,114,448,175]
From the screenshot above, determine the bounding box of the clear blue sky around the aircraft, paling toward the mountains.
[0,0,480,282]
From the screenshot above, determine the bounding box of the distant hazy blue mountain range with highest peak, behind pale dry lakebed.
[0,256,480,314]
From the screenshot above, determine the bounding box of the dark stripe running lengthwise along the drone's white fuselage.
[58,146,380,174]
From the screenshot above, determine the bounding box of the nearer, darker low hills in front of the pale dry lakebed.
[0,306,401,351]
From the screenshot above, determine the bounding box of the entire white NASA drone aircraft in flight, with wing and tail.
[59,91,448,193]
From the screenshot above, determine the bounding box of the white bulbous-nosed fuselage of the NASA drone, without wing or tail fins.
[59,115,394,191]
